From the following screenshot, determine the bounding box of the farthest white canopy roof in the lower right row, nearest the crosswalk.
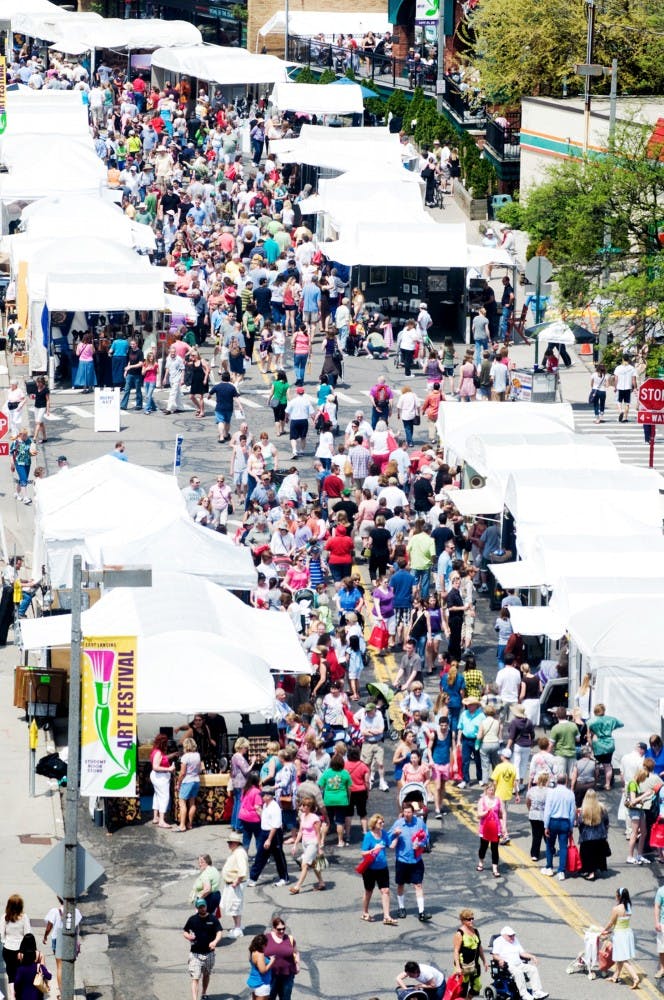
[438,402,574,461]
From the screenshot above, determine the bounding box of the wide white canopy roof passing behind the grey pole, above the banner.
[22,572,311,672]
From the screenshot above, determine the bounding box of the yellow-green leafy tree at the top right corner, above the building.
[470,0,664,104]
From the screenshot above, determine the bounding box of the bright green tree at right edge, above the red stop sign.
[522,124,664,333]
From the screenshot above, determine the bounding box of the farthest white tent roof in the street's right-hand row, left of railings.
[152,45,288,86]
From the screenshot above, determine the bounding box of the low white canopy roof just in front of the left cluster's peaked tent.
[97,518,256,592]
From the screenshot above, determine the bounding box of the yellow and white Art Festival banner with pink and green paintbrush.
[81,636,137,798]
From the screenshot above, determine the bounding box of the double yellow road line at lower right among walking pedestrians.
[446,786,661,1000]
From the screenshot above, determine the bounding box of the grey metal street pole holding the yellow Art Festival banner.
[62,556,152,1000]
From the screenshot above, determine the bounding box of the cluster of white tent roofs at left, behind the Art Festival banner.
[21,455,309,716]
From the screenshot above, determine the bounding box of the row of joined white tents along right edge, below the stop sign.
[438,402,664,751]
